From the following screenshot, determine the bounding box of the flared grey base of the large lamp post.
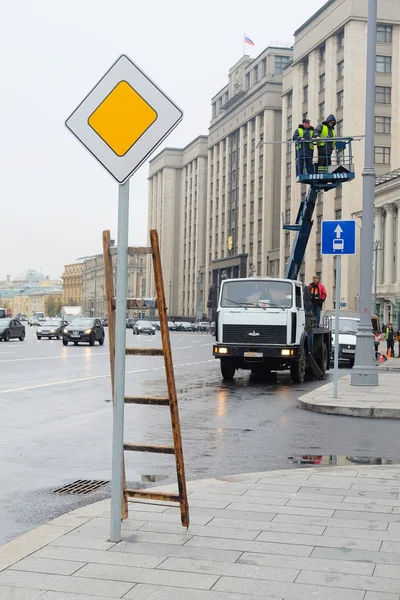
[351,322,379,386]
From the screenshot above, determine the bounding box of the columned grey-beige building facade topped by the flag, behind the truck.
[205,47,292,300]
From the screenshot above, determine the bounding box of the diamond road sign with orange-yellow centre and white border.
[65,55,183,183]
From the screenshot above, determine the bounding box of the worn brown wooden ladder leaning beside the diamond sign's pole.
[103,229,189,527]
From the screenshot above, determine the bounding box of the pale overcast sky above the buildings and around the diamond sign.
[0,0,324,279]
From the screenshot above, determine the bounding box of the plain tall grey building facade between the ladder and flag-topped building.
[146,135,207,317]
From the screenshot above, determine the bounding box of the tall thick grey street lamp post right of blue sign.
[351,0,379,386]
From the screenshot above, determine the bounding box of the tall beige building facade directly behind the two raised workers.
[280,0,400,309]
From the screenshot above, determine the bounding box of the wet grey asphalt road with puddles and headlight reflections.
[0,327,399,545]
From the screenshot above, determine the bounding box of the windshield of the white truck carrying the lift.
[220,279,293,310]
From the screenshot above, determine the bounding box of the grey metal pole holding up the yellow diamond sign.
[110,180,129,542]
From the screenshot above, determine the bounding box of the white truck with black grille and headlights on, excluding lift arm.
[213,277,331,382]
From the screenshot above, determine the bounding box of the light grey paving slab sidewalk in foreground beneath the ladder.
[0,465,400,600]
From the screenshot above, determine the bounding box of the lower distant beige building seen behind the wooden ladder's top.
[82,247,146,317]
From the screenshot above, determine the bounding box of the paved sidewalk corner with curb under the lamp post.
[297,358,400,419]
